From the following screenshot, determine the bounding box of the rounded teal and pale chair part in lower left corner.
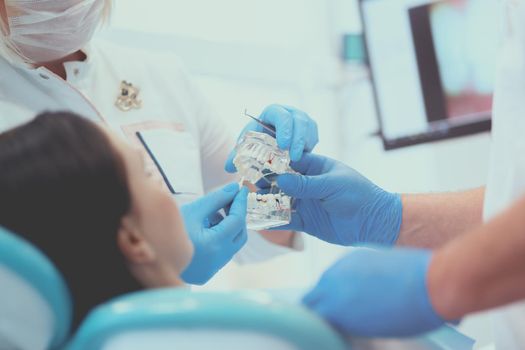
[0,227,72,350]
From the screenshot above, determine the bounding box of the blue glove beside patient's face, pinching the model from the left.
[181,183,248,284]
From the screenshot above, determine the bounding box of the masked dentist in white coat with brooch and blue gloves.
[0,0,317,284]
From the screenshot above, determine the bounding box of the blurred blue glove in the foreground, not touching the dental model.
[303,248,444,337]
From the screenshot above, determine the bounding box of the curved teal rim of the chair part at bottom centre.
[68,288,346,350]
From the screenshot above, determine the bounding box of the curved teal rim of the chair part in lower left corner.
[0,227,72,348]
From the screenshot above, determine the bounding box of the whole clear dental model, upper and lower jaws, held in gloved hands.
[233,131,294,230]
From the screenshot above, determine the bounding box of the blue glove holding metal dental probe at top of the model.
[224,105,319,173]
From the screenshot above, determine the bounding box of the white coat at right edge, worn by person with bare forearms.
[484,0,525,350]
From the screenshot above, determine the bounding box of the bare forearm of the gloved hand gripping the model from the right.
[397,188,485,249]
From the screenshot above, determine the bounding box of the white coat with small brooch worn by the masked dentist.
[0,41,301,262]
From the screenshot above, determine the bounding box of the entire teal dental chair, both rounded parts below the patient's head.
[0,224,345,350]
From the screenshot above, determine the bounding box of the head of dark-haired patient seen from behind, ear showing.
[0,113,193,328]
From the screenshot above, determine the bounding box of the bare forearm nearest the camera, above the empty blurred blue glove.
[428,194,525,319]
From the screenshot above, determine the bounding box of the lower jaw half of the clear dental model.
[246,192,292,230]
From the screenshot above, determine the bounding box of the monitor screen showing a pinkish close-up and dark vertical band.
[360,0,500,149]
